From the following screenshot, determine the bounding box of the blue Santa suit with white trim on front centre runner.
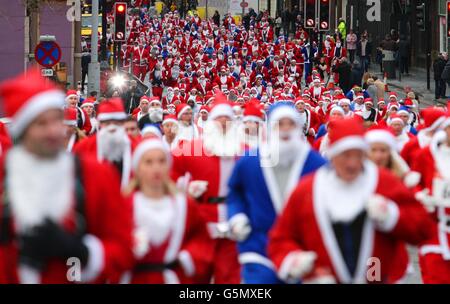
[227,143,326,284]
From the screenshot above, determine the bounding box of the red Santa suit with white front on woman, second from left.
[122,192,212,284]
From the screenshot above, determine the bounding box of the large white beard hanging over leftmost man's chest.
[6,146,74,232]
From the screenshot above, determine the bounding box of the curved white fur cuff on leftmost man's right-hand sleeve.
[81,234,105,282]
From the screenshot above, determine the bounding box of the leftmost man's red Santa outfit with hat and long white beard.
[0,69,132,284]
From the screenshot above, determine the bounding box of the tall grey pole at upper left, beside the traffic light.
[88,0,100,94]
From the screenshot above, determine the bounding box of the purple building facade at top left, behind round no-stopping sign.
[0,0,74,83]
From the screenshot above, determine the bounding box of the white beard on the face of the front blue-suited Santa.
[269,129,305,168]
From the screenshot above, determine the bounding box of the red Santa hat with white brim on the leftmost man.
[0,69,64,137]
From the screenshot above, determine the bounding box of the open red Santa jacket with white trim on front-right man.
[268,163,430,283]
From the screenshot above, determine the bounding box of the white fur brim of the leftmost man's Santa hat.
[9,90,64,137]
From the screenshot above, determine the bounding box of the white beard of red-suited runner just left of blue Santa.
[203,120,241,157]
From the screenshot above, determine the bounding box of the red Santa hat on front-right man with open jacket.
[327,118,367,158]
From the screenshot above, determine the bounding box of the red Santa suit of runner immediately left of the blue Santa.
[172,97,240,284]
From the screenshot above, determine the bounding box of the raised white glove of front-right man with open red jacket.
[366,194,398,231]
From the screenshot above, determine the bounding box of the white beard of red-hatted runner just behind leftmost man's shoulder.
[98,125,129,162]
